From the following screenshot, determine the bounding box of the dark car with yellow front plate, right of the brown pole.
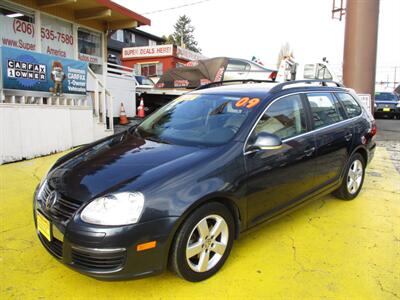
[374,92,400,119]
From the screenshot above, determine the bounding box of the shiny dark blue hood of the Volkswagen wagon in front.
[48,132,213,202]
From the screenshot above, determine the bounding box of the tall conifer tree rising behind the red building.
[165,15,201,53]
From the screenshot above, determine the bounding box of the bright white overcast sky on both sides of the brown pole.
[114,0,400,81]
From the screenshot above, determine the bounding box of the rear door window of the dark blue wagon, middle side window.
[307,93,344,129]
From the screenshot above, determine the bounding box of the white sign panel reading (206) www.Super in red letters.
[0,15,36,51]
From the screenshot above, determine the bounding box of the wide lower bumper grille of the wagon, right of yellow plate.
[71,248,125,272]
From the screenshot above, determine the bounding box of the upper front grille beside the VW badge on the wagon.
[41,184,81,221]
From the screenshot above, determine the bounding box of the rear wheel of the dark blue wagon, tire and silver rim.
[333,153,366,200]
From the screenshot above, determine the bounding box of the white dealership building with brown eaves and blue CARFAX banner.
[0,0,150,164]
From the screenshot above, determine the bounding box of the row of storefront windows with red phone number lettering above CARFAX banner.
[0,0,103,74]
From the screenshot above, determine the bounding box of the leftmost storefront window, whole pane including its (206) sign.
[0,3,36,51]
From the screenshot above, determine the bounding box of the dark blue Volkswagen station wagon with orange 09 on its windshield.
[34,81,376,281]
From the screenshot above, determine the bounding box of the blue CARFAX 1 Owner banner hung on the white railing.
[1,47,87,95]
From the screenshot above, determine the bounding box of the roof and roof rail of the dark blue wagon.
[193,82,347,98]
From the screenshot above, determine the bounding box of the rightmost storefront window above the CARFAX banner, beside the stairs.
[78,28,103,74]
